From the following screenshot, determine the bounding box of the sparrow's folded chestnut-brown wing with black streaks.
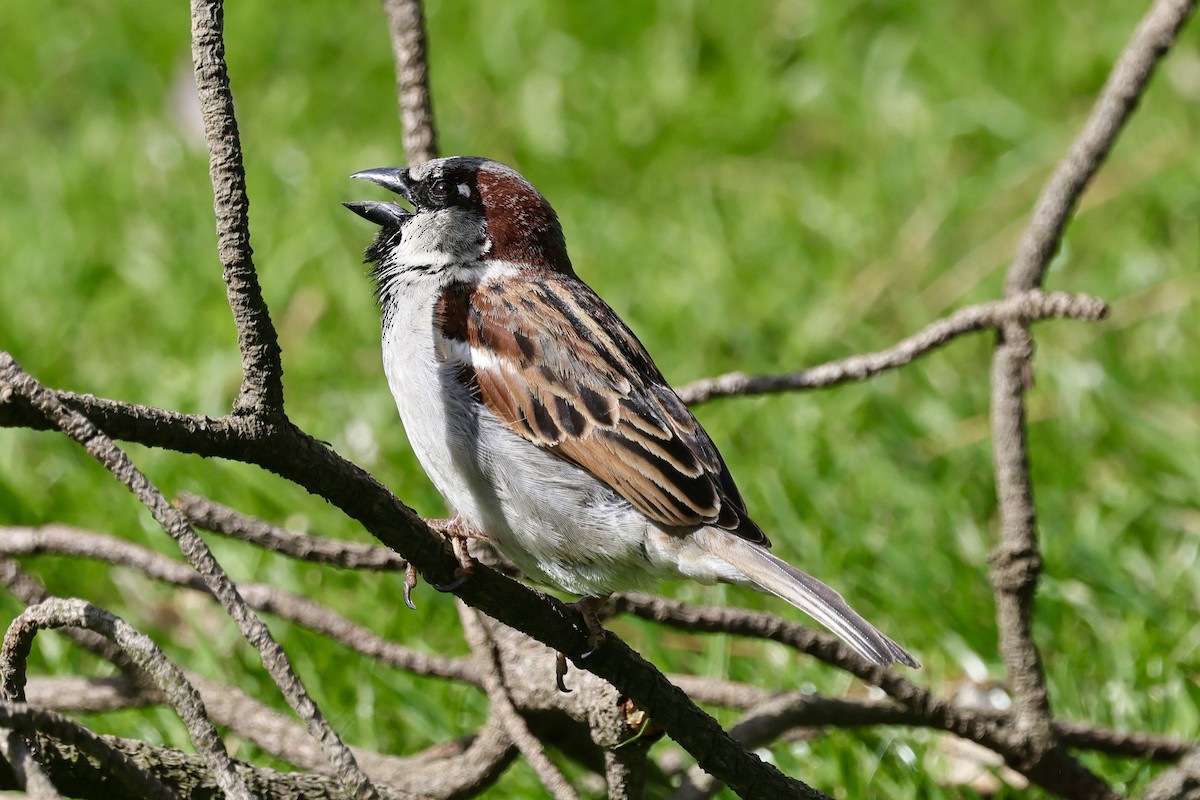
[434,273,769,546]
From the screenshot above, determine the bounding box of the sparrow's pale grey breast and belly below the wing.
[384,305,676,595]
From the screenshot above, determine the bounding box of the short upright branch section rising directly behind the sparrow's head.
[383,0,438,164]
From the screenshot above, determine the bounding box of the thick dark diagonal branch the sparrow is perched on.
[0,367,824,798]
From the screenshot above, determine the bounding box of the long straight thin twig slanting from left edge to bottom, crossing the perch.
[0,351,378,800]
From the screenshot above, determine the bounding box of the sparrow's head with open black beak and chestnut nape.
[344,156,571,291]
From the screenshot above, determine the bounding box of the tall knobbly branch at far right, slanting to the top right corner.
[990,0,1195,799]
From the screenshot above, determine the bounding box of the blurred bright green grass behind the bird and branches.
[0,0,1200,798]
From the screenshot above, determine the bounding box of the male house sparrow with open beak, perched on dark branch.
[346,156,919,667]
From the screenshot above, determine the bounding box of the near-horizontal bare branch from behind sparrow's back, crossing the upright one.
[677,291,1109,405]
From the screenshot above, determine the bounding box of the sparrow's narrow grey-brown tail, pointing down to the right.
[720,535,920,668]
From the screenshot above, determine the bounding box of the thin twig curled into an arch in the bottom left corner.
[0,599,251,800]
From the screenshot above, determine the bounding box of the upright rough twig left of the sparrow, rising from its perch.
[192,0,283,414]
